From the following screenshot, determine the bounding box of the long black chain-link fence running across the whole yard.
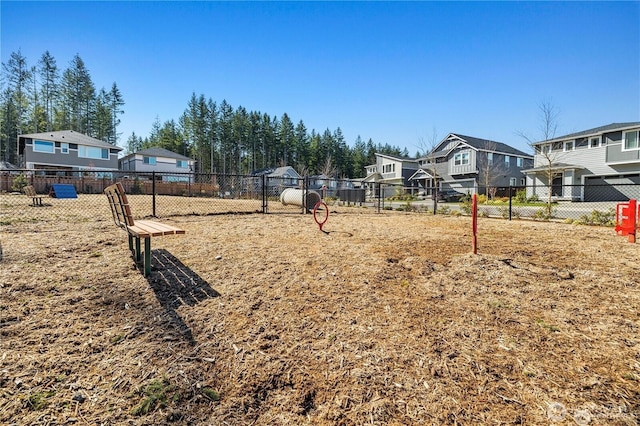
[0,170,640,230]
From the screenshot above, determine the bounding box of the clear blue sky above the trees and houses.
[0,0,640,155]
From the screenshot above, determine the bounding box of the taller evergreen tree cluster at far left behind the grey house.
[0,51,124,163]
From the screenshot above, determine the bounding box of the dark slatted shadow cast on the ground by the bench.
[147,249,220,345]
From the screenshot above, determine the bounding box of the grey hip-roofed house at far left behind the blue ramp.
[18,130,122,172]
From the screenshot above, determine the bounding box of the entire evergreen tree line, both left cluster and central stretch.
[0,51,409,178]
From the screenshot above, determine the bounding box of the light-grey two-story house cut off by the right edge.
[525,122,640,201]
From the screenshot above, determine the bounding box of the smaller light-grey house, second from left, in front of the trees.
[119,147,195,182]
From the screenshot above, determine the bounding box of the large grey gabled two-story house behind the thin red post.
[410,133,533,195]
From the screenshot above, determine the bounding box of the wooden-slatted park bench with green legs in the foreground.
[104,182,185,277]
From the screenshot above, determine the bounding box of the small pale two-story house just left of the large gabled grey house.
[362,153,418,197]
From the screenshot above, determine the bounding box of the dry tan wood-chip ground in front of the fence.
[0,206,640,425]
